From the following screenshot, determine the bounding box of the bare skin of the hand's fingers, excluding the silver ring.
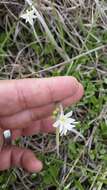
[0,77,83,172]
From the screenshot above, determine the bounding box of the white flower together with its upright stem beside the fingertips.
[53,105,84,156]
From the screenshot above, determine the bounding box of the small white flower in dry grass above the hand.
[20,6,37,27]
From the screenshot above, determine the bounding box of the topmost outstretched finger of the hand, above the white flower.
[0,76,78,116]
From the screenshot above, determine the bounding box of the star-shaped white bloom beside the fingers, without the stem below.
[53,105,84,138]
